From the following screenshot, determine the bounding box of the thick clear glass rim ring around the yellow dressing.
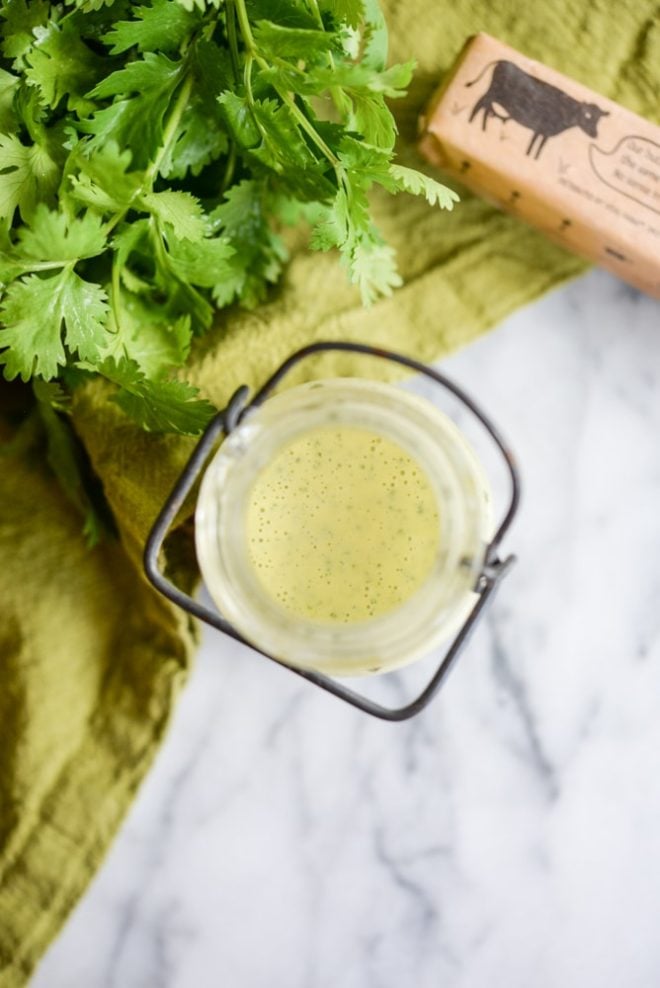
[196,378,492,675]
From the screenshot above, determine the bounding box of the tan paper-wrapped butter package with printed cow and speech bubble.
[420,34,660,298]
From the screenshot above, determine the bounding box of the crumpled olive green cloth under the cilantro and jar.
[0,0,660,988]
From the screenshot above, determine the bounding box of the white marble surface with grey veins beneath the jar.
[33,272,660,988]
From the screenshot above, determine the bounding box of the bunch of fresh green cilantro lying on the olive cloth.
[0,0,454,433]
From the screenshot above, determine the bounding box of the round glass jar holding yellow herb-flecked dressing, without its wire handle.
[196,378,493,676]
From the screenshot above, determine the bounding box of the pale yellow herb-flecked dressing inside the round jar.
[246,425,440,623]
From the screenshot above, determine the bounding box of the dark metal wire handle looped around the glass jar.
[144,341,520,721]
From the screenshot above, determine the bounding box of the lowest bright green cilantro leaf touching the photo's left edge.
[0,268,108,381]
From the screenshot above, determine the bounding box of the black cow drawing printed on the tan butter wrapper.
[466,59,608,158]
